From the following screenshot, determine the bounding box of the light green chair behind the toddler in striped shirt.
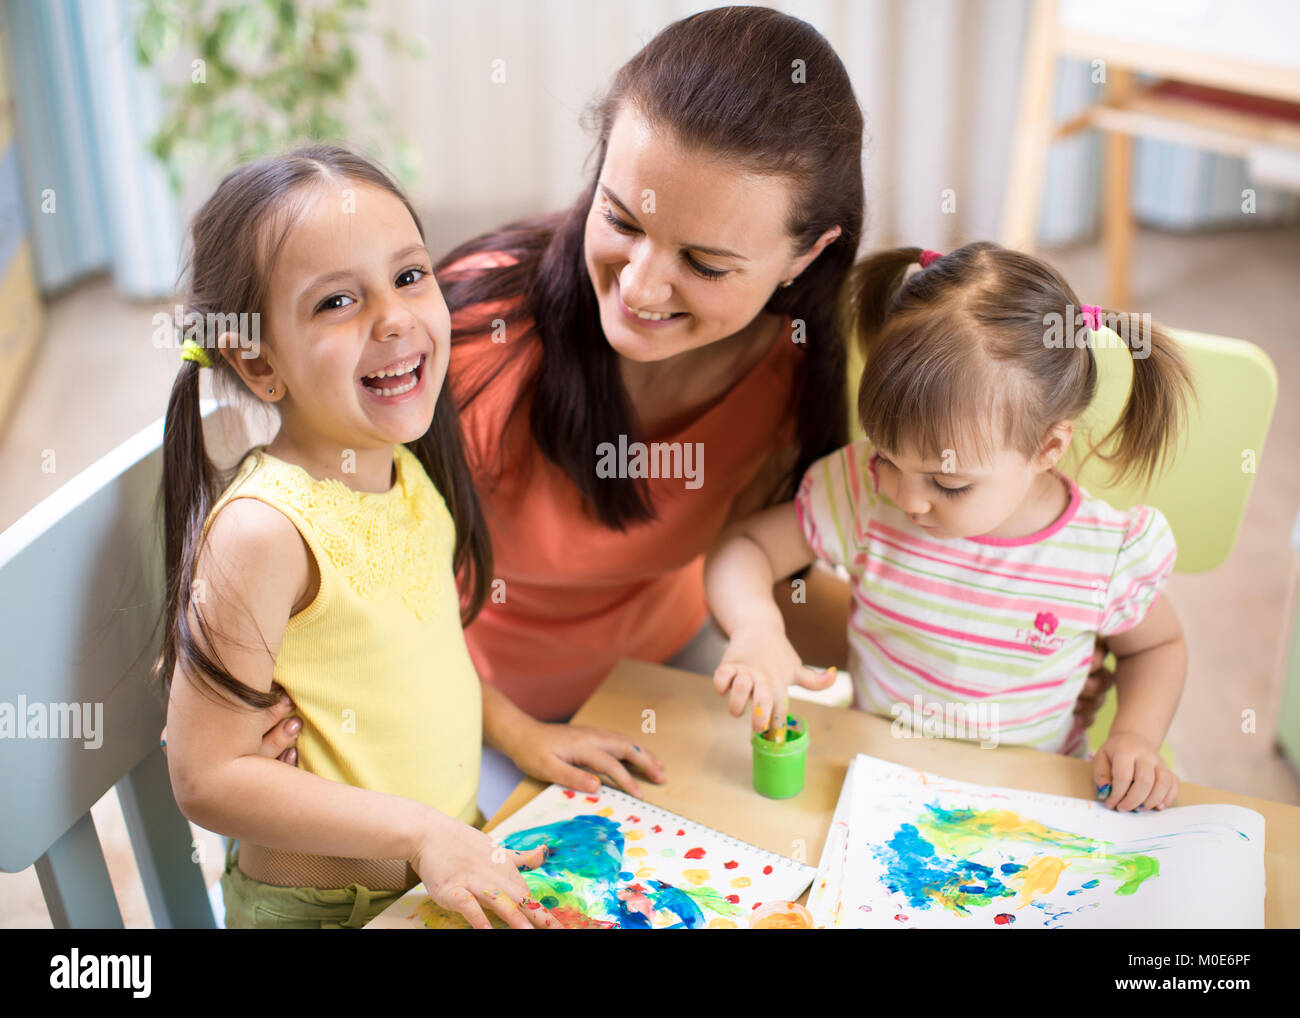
[849,322,1278,766]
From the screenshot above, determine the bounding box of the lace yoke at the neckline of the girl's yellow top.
[241,445,455,621]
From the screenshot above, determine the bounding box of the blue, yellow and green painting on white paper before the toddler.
[809,757,1264,930]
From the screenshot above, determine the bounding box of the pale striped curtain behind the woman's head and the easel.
[359,0,1297,250]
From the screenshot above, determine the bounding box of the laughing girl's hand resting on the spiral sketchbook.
[411,814,564,930]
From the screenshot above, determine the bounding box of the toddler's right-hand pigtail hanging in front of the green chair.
[1097,309,1196,485]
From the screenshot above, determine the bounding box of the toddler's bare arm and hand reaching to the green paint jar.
[705,502,835,732]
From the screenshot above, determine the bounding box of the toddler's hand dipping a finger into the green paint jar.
[714,627,836,732]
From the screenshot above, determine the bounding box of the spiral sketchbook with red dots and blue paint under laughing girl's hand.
[371,785,814,930]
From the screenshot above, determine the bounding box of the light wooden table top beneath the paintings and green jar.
[484,660,1300,928]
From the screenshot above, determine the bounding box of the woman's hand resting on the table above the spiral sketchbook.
[502,718,664,798]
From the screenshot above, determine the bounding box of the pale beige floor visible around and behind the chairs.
[0,229,1300,928]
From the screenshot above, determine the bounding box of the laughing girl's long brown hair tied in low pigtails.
[155,144,491,709]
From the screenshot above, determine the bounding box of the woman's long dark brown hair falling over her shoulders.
[436,7,863,529]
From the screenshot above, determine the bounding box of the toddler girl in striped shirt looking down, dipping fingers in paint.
[705,243,1192,810]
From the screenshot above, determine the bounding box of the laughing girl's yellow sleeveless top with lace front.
[203,445,482,868]
